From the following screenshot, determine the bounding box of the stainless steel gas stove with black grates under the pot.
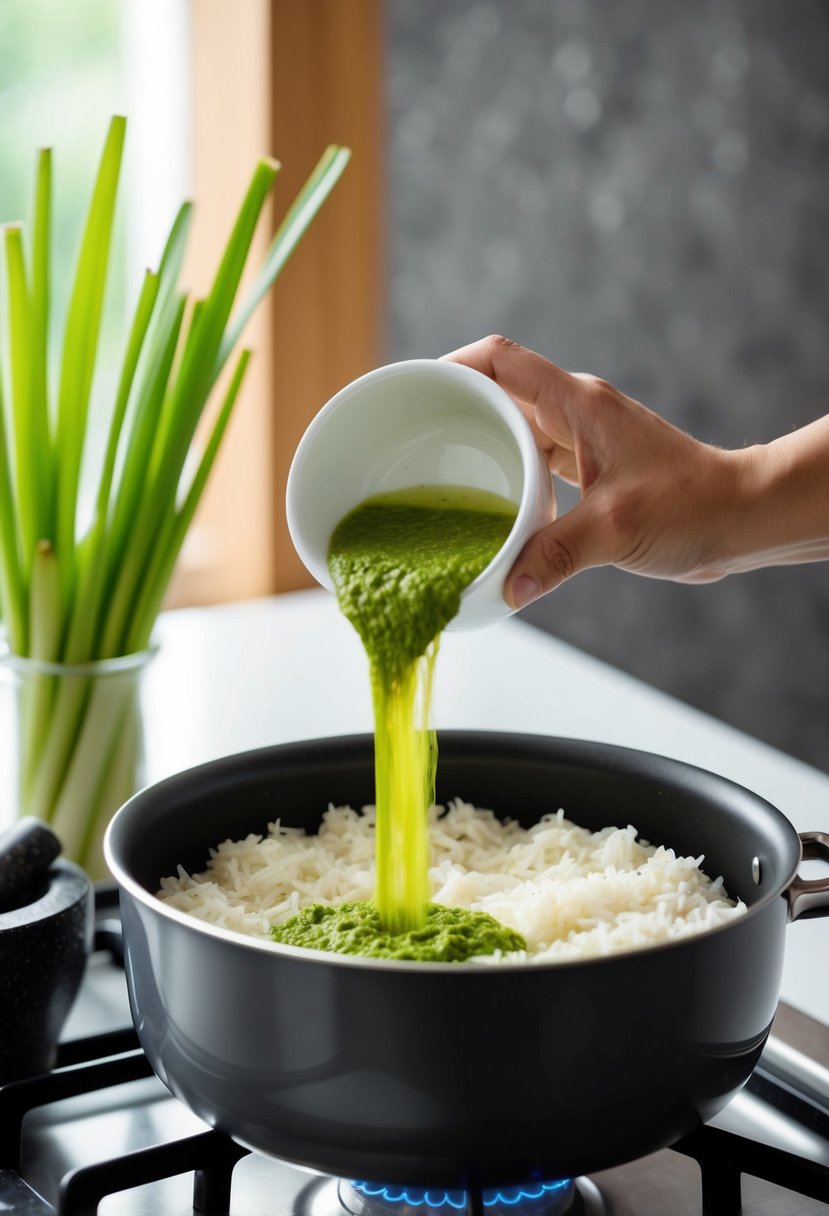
[0,886,829,1216]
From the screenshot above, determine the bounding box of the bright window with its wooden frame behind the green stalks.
[0,0,382,604]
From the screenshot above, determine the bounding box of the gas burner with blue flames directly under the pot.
[337,1178,607,1216]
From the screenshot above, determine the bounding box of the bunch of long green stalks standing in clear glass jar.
[0,117,350,877]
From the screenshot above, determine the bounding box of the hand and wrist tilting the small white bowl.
[444,337,829,608]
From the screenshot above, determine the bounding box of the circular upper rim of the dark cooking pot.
[103,730,802,976]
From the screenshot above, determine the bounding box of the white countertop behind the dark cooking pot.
[146,591,829,1024]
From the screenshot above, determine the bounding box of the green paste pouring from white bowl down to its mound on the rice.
[272,485,525,962]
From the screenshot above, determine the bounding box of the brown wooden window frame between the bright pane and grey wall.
[169,0,383,606]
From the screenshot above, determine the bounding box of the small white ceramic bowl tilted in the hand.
[287,359,556,629]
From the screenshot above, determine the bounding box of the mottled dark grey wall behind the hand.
[387,0,829,769]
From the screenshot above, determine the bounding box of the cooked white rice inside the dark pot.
[158,801,745,962]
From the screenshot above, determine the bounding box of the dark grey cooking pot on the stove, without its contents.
[106,732,829,1186]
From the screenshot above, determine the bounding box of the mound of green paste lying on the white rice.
[271,901,526,963]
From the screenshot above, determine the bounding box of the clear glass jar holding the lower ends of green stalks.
[0,648,156,879]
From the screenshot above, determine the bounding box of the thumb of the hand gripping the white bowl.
[504,497,613,608]
